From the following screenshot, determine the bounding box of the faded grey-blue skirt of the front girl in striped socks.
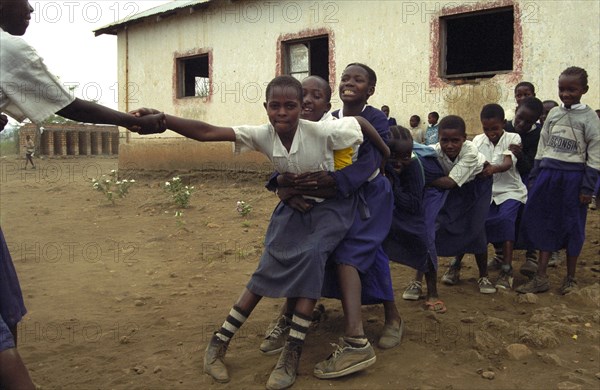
[247,196,357,299]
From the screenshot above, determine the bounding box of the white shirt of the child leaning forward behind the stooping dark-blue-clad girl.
[433,140,486,187]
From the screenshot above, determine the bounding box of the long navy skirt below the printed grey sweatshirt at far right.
[520,168,588,256]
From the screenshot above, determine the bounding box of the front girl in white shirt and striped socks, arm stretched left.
[131,76,384,389]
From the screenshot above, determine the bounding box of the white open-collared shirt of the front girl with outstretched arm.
[233,117,363,174]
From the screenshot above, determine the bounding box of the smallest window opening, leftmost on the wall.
[177,55,210,98]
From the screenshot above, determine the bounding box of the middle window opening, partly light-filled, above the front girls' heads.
[285,36,329,81]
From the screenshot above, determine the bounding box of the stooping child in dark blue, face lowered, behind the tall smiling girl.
[383,126,446,314]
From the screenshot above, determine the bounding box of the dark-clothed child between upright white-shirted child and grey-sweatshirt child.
[489,97,543,277]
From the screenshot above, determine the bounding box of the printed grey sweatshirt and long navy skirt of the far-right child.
[521,104,600,256]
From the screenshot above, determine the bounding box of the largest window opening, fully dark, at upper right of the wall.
[440,7,514,78]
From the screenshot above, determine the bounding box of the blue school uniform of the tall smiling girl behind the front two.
[322,106,394,304]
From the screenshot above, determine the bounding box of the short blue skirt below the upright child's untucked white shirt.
[485,199,523,243]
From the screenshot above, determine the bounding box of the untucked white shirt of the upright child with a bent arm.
[473,131,527,205]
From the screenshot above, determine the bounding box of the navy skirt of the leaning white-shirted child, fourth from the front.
[435,178,492,257]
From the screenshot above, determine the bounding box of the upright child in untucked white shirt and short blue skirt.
[473,104,527,290]
